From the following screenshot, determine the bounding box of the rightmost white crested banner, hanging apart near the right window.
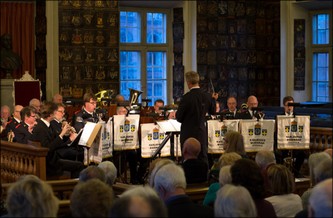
[277,116,310,149]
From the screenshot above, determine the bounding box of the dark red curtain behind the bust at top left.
[0,2,35,79]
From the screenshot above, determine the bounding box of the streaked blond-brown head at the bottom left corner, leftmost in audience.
[6,175,59,217]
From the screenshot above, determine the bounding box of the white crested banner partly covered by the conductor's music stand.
[141,123,170,158]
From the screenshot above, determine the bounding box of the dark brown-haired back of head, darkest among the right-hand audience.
[231,158,265,199]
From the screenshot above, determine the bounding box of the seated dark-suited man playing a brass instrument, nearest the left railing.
[32,102,84,178]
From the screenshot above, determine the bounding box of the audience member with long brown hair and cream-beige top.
[266,164,303,217]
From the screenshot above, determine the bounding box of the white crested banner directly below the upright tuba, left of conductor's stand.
[113,114,140,151]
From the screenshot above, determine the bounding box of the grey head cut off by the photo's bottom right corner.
[308,178,333,217]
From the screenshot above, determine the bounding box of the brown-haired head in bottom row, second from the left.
[70,179,114,217]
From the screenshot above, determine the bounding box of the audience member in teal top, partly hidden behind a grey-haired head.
[202,165,232,206]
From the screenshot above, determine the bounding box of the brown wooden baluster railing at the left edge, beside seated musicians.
[0,140,48,183]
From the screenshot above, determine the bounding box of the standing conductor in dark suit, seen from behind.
[176,71,218,166]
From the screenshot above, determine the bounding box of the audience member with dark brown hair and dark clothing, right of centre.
[231,158,277,217]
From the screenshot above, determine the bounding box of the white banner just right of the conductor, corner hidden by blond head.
[207,120,239,154]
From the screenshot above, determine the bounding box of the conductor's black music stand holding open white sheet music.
[152,119,181,161]
